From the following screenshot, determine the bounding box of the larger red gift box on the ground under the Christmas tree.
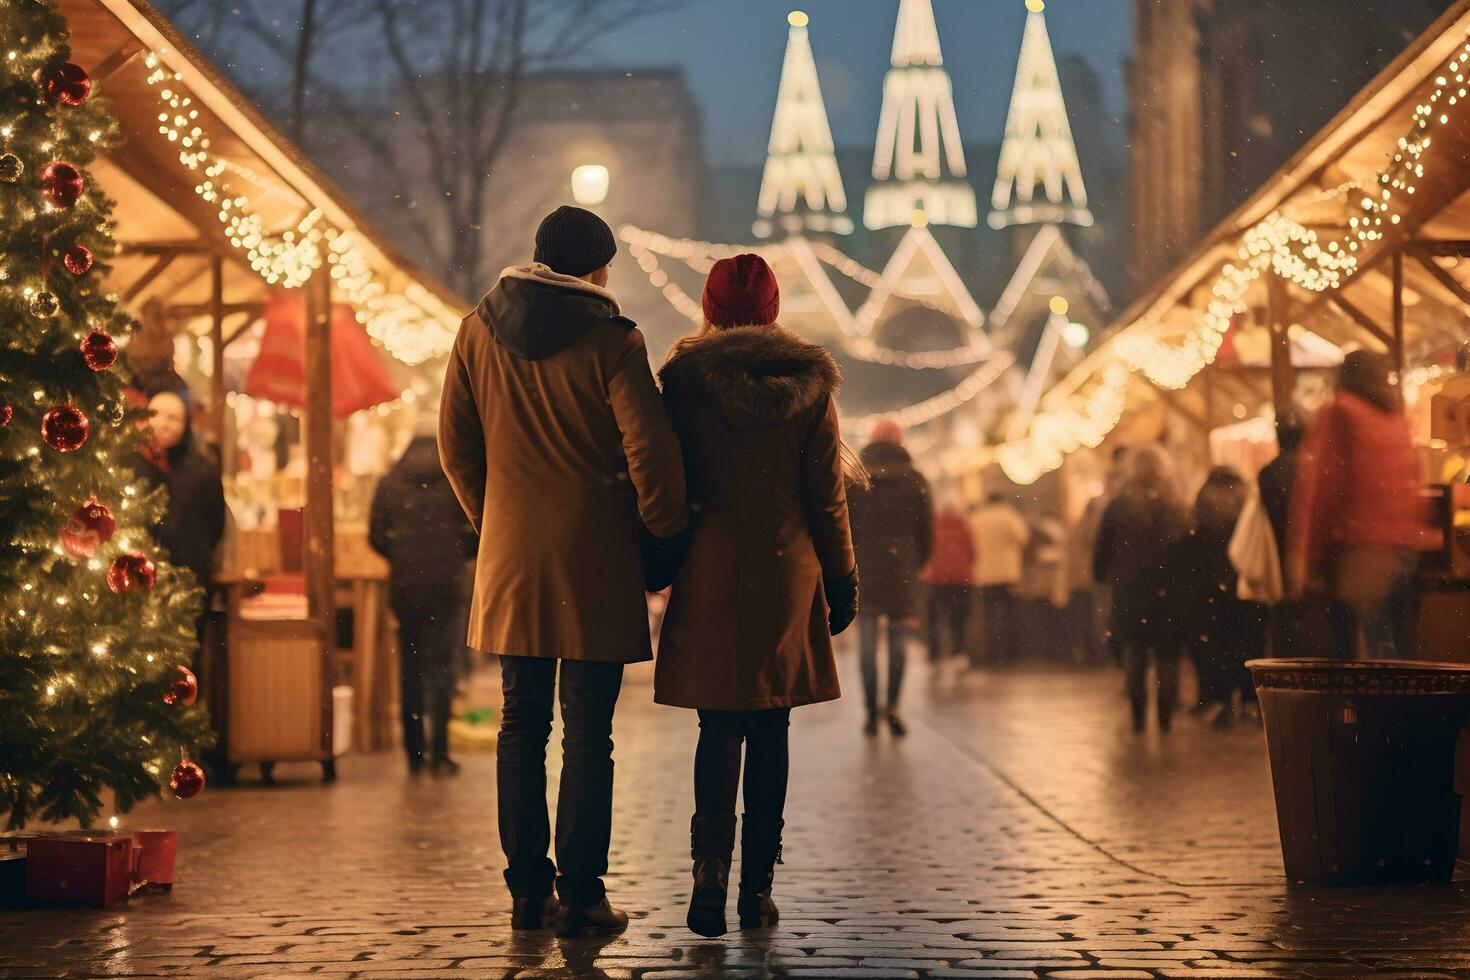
[25,833,133,905]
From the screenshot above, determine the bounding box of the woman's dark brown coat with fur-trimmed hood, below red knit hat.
[654,326,854,711]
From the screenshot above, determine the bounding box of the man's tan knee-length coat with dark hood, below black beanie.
[440,266,686,663]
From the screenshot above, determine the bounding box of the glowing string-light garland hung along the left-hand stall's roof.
[144,51,459,366]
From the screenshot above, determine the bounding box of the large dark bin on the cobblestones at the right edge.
[1247,660,1470,884]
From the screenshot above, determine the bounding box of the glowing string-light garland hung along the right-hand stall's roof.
[991,32,1470,483]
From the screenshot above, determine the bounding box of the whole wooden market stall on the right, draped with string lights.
[944,0,1470,660]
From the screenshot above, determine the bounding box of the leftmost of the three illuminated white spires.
[754,10,853,238]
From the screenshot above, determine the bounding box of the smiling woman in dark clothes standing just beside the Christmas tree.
[132,391,225,602]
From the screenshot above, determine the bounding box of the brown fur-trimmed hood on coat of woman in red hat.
[659,323,842,428]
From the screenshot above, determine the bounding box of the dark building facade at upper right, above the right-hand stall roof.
[1127,0,1451,291]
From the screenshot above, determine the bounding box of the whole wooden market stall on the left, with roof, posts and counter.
[59,0,465,774]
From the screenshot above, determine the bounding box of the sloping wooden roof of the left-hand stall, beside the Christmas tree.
[59,0,467,363]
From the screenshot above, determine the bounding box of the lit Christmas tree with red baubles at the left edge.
[0,0,207,827]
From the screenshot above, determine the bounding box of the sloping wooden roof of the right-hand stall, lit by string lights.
[970,0,1470,483]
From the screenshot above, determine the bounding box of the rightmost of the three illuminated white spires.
[989,0,1092,228]
